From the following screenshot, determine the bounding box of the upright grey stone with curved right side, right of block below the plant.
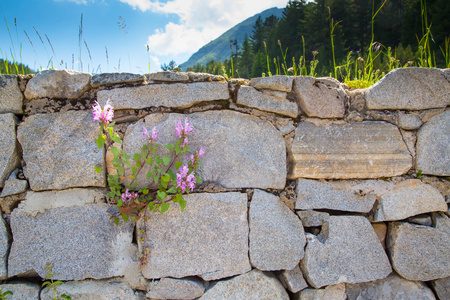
[249,190,306,271]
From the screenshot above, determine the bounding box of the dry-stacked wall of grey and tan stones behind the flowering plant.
[0,68,450,300]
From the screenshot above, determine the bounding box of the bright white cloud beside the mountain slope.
[123,0,288,60]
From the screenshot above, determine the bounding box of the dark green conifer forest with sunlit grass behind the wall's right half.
[183,0,450,79]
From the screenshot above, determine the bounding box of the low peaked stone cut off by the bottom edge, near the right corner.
[346,273,435,300]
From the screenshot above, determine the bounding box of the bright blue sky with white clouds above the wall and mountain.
[0,0,288,73]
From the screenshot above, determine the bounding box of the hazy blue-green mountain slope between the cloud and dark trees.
[180,7,283,71]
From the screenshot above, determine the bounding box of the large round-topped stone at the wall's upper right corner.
[365,68,450,110]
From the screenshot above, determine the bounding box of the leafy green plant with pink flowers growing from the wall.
[93,100,205,264]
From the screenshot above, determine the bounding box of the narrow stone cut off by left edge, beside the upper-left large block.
[0,113,20,187]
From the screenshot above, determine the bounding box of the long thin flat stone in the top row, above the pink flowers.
[97,82,230,109]
